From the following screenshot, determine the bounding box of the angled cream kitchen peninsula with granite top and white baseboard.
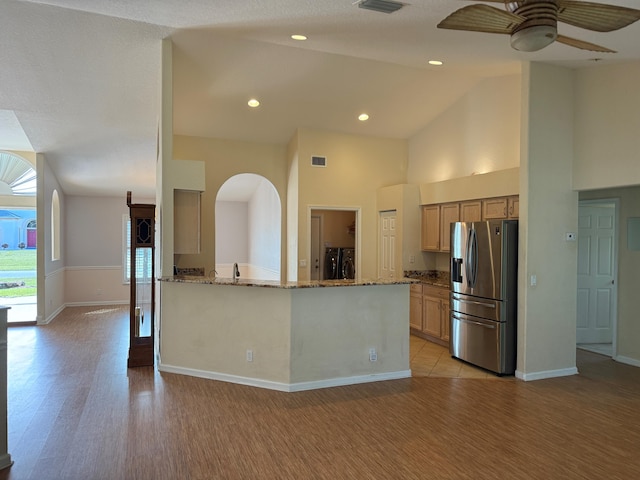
[158,276,413,392]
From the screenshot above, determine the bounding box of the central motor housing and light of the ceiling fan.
[511,0,558,52]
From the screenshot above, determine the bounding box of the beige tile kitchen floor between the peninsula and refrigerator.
[409,335,510,379]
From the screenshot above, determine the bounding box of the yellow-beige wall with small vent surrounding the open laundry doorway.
[298,129,407,280]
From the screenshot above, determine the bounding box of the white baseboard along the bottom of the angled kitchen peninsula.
[158,362,411,392]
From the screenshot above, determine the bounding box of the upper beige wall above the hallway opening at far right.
[573,60,640,190]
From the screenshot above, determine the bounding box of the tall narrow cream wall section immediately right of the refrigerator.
[516,63,578,380]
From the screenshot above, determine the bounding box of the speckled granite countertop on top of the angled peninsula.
[158,275,418,289]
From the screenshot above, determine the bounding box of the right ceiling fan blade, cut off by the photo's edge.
[558,0,640,32]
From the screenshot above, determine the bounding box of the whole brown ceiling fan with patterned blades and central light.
[438,0,640,53]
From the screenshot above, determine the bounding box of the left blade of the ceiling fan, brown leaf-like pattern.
[438,5,525,34]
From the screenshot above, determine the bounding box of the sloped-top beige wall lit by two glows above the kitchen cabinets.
[405,74,521,184]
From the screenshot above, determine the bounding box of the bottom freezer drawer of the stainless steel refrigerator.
[450,312,515,375]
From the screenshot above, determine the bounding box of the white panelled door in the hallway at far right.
[576,202,617,344]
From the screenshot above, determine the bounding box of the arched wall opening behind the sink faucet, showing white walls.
[215,173,282,280]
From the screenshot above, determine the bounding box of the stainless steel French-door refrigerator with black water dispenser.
[449,220,518,375]
